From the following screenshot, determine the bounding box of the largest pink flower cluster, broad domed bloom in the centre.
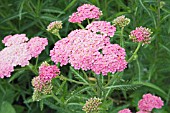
[50,30,127,75]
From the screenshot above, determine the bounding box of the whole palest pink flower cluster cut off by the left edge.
[0,34,48,78]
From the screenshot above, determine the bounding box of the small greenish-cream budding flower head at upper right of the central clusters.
[112,15,130,27]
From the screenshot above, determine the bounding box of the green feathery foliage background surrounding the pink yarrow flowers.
[0,0,170,113]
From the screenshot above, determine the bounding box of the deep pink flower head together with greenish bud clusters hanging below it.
[32,62,60,101]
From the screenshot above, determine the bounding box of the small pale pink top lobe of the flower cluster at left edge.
[2,34,28,46]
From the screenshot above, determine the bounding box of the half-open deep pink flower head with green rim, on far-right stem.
[129,26,152,44]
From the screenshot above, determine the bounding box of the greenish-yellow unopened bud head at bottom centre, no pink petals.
[82,97,102,113]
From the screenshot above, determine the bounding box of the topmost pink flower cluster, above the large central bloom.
[69,4,102,23]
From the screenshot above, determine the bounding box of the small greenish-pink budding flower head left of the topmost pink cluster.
[47,21,62,35]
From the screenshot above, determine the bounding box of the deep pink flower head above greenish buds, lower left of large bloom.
[39,63,60,82]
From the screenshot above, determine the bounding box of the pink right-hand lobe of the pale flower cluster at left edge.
[27,37,48,58]
